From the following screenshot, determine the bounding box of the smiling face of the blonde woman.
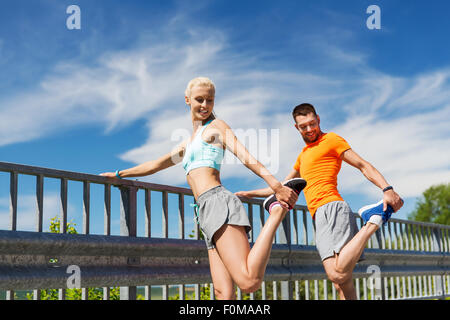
[185,85,215,122]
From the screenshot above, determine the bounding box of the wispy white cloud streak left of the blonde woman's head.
[0,32,225,146]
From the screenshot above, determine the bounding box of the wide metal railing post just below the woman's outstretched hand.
[120,186,137,300]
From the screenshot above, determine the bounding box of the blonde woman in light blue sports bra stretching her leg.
[102,77,304,299]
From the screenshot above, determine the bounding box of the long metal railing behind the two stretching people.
[0,162,450,300]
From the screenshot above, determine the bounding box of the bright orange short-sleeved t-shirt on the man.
[294,132,350,218]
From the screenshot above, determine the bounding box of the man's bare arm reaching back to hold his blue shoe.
[341,149,403,212]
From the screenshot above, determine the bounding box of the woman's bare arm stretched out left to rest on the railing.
[100,141,186,178]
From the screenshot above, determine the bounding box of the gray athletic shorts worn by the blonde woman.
[197,185,251,250]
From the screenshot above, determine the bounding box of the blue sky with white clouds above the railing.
[0,0,450,235]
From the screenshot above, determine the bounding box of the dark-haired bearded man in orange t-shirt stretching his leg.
[236,103,403,299]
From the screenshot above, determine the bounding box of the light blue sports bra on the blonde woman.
[182,120,225,175]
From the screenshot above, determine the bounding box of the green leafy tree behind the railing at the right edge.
[408,183,450,225]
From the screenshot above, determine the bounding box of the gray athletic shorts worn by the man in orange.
[315,201,364,261]
